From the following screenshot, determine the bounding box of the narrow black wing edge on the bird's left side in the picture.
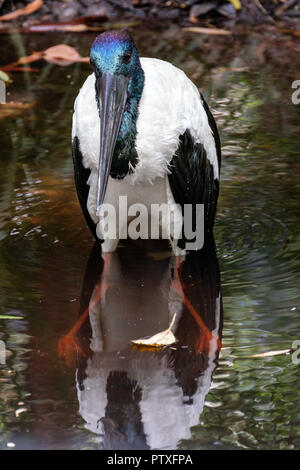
[72,137,99,240]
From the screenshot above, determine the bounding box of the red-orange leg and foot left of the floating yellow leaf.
[58,253,111,365]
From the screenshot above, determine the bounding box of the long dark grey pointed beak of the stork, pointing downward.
[96,73,128,212]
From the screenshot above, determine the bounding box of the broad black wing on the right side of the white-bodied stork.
[169,99,221,252]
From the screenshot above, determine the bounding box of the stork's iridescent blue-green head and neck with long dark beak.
[90,31,144,210]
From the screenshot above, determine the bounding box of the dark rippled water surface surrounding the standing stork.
[0,27,300,449]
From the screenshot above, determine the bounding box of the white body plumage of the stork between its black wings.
[72,58,219,252]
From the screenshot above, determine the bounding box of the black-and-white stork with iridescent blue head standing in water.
[72,31,221,255]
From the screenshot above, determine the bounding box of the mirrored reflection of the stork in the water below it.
[77,244,222,450]
